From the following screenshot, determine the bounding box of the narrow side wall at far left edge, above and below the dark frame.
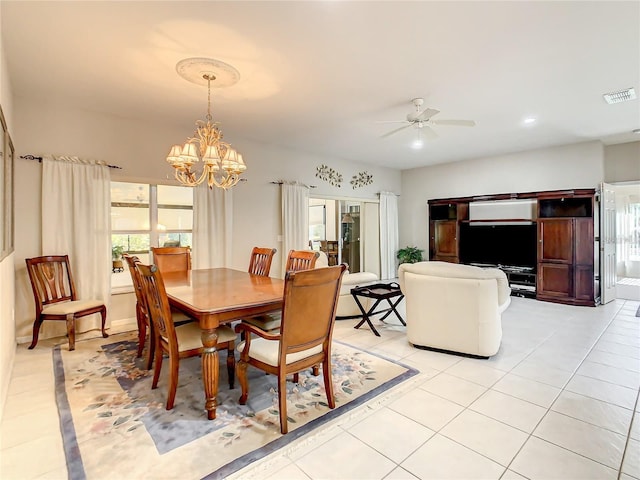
[0,19,16,420]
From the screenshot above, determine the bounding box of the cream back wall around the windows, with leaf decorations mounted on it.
[14,98,401,339]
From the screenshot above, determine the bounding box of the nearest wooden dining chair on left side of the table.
[135,263,236,410]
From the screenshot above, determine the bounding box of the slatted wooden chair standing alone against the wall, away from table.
[25,255,109,350]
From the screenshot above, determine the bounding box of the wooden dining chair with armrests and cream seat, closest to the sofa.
[236,264,347,434]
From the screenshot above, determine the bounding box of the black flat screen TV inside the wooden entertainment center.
[459,223,537,270]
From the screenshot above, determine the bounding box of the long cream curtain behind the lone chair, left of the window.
[42,157,111,338]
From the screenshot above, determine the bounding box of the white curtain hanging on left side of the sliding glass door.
[281,182,309,276]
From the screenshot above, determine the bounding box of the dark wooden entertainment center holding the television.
[429,189,600,306]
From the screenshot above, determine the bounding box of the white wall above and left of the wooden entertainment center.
[398,142,604,254]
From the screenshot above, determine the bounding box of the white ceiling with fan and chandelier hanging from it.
[0,0,640,169]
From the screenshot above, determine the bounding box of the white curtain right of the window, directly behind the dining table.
[192,183,233,269]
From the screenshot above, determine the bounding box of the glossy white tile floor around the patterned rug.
[0,298,640,480]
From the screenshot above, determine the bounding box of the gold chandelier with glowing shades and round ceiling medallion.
[167,58,247,190]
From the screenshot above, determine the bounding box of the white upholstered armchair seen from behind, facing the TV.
[398,261,511,357]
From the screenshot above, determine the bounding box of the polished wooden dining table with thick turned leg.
[162,268,284,420]
